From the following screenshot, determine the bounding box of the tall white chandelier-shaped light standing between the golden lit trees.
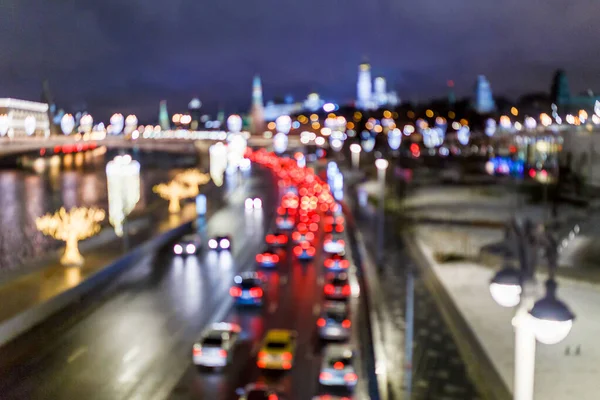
[106,154,140,236]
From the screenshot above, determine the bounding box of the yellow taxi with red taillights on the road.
[256,329,298,371]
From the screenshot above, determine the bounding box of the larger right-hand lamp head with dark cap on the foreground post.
[529,280,575,344]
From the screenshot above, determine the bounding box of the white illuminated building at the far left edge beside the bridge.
[0,98,50,139]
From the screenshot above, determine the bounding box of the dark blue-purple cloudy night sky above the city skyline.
[0,0,600,120]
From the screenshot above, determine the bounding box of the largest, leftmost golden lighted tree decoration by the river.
[35,207,105,267]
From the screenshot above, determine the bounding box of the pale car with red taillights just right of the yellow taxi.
[319,344,358,389]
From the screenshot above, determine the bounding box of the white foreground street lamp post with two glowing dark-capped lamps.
[490,221,575,400]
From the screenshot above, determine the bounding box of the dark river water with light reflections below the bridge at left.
[0,148,198,274]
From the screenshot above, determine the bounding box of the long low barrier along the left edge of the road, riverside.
[0,221,193,346]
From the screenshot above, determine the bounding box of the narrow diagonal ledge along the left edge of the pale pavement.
[402,233,512,400]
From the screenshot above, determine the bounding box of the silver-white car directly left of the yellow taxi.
[192,322,241,367]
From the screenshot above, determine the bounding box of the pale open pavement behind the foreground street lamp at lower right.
[413,231,600,400]
